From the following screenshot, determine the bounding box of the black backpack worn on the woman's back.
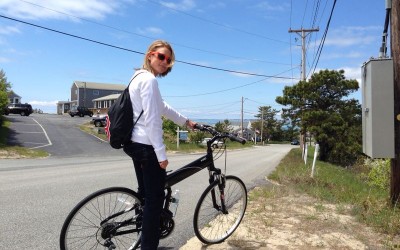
[105,73,143,149]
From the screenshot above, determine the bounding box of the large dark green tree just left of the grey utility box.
[276,70,362,165]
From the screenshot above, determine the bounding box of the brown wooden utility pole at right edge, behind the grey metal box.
[387,1,400,205]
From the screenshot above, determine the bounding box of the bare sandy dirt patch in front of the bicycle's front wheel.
[180,185,394,250]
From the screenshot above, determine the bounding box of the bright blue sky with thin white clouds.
[0,0,390,120]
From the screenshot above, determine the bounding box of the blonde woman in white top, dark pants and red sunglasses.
[124,40,196,249]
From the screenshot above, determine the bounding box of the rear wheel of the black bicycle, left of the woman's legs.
[60,187,141,250]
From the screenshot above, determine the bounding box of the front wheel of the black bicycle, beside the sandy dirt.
[193,176,247,244]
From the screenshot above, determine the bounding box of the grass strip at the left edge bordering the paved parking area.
[0,117,49,159]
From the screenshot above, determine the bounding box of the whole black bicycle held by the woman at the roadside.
[60,125,247,249]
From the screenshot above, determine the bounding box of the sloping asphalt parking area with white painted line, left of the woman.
[7,114,124,157]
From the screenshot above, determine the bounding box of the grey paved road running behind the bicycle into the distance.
[0,116,292,250]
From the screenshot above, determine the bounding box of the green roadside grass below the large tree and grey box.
[268,149,400,237]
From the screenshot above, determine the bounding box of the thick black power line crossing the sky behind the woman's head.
[0,15,292,79]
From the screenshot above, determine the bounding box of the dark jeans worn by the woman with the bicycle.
[124,143,166,250]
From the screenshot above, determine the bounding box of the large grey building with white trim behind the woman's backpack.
[57,81,126,114]
